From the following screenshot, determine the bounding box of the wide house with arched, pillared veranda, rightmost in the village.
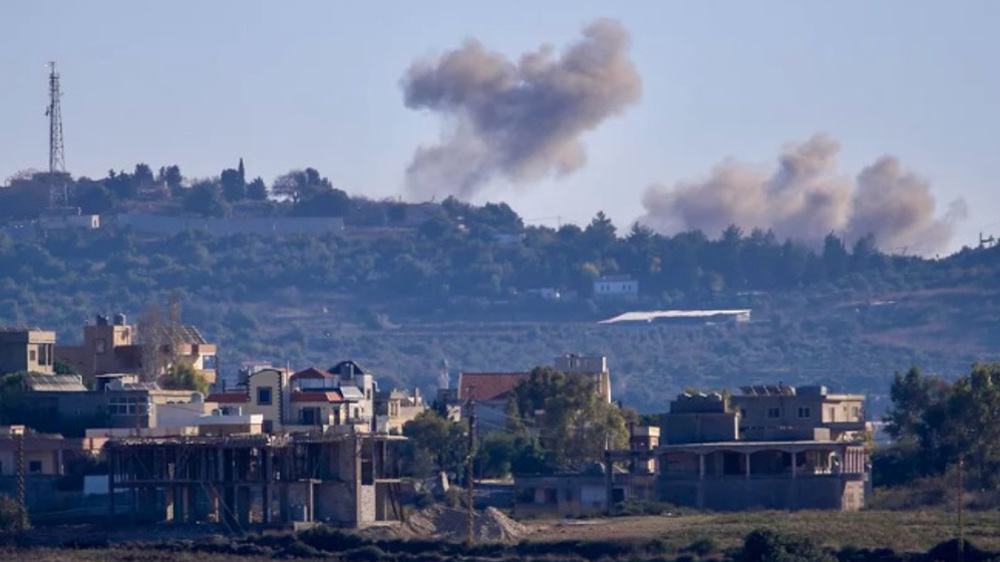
[656,386,871,510]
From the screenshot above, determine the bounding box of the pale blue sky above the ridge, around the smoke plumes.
[0,0,1000,253]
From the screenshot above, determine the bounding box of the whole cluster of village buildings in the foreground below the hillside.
[0,314,872,532]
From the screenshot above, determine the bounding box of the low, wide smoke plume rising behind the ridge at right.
[641,134,965,253]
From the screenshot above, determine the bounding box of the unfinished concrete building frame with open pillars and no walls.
[105,434,402,531]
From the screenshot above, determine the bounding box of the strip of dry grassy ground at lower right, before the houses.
[525,511,1000,551]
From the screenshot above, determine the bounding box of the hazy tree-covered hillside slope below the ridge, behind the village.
[0,200,1000,411]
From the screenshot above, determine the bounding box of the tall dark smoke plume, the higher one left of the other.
[402,20,642,198]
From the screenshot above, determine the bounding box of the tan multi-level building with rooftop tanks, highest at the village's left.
[55,314,218,384]
